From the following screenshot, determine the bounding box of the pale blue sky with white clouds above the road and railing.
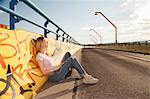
[0,0,150,44]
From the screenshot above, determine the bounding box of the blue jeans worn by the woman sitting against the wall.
[48,52,85,81]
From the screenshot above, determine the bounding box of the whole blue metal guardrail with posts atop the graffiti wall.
[0,0,81,45]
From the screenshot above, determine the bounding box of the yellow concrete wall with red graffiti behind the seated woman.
[0,28,81,99]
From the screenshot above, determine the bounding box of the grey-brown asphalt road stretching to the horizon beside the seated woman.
[77,49,150,99]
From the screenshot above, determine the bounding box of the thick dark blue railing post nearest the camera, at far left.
[9,0,19,30]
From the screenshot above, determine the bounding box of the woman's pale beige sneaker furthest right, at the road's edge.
[83,75,98,84]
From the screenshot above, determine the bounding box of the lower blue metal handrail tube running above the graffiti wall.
[0,5,77,44]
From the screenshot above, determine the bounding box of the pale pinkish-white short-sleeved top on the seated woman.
[36,53,56,72]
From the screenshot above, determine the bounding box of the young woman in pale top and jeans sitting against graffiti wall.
[36,37,98,84]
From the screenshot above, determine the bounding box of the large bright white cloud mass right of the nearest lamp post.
[119,0,150,41]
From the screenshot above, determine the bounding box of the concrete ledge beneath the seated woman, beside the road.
[36,80,75,99]
